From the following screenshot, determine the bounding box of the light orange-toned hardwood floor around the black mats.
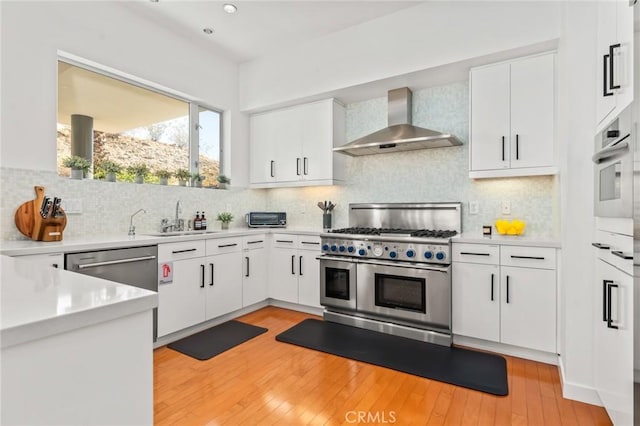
[154,307,611,426]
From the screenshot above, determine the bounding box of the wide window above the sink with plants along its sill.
[57,60,222,186]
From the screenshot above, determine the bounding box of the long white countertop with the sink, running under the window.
[0,228,323,256]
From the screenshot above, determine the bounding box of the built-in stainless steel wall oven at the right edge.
[593,106,636,217]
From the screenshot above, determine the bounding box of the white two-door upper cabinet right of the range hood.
[469,53,557,178]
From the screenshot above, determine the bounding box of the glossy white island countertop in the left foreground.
[0,256,158,348]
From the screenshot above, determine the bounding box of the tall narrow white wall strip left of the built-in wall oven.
[558,2,598,403]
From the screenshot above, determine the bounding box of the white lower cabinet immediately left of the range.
[269,234,320,307]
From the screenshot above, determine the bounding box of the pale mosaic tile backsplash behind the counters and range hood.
[0,82,559,240]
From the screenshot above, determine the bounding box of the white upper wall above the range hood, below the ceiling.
[240,1,561,111]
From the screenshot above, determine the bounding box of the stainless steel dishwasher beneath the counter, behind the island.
[64,246,158,342]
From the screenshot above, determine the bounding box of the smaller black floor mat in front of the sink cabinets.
[167,320,267,361]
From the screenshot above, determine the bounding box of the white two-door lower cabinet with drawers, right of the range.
[452,244,556,353]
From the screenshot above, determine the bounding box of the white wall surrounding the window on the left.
[0,1,248,184]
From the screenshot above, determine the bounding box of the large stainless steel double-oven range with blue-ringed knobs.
[319,203,462,346]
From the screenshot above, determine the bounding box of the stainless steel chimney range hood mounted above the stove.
[333,87,462,157]
